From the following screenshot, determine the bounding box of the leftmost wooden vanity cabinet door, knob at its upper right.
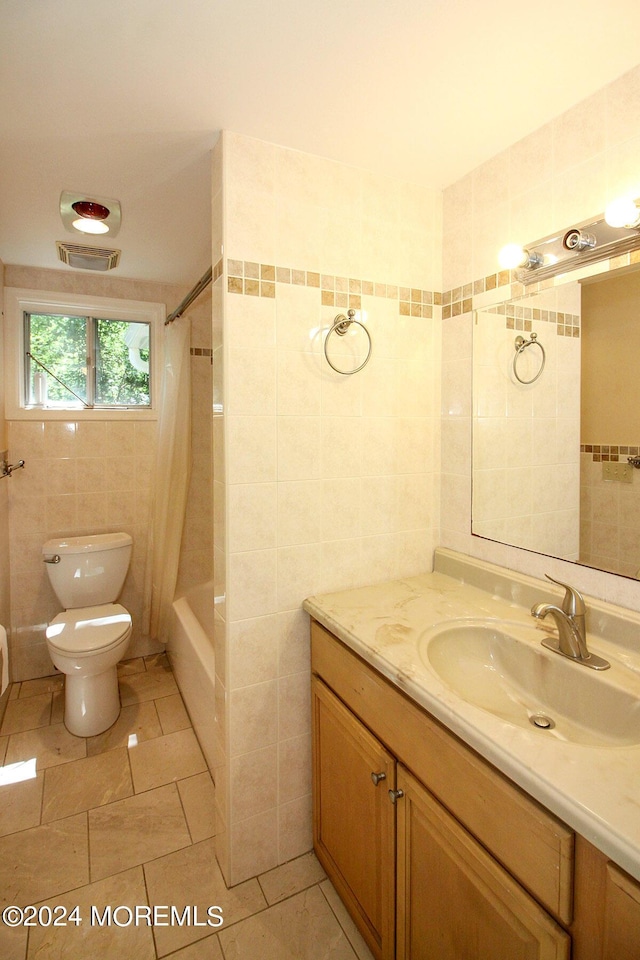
[312,677,395,960]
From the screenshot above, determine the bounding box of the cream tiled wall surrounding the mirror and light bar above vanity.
[441,67,640,610]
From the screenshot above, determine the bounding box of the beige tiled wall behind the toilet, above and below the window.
[0,266,186,680]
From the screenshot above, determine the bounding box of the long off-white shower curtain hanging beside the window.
[145,319,191,643]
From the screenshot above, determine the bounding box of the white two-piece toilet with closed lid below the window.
[42,533,132,737]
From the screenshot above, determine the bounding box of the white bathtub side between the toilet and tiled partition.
[167,581,215,775]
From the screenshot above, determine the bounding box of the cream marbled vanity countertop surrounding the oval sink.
[304,561,640,881]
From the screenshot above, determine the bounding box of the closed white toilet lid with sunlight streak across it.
[47,603,131,653]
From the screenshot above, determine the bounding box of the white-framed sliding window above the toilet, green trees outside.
[5,288,166,419]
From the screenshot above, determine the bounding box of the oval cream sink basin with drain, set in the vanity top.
[418,619,640,747]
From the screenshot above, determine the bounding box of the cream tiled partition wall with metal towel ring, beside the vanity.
[214,133,441,883]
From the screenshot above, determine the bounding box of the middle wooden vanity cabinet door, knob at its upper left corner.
[396,765,571,960]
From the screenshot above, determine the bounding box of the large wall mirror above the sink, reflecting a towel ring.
[472,265,640,579]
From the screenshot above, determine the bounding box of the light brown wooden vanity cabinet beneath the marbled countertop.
[311,621,608,960]
